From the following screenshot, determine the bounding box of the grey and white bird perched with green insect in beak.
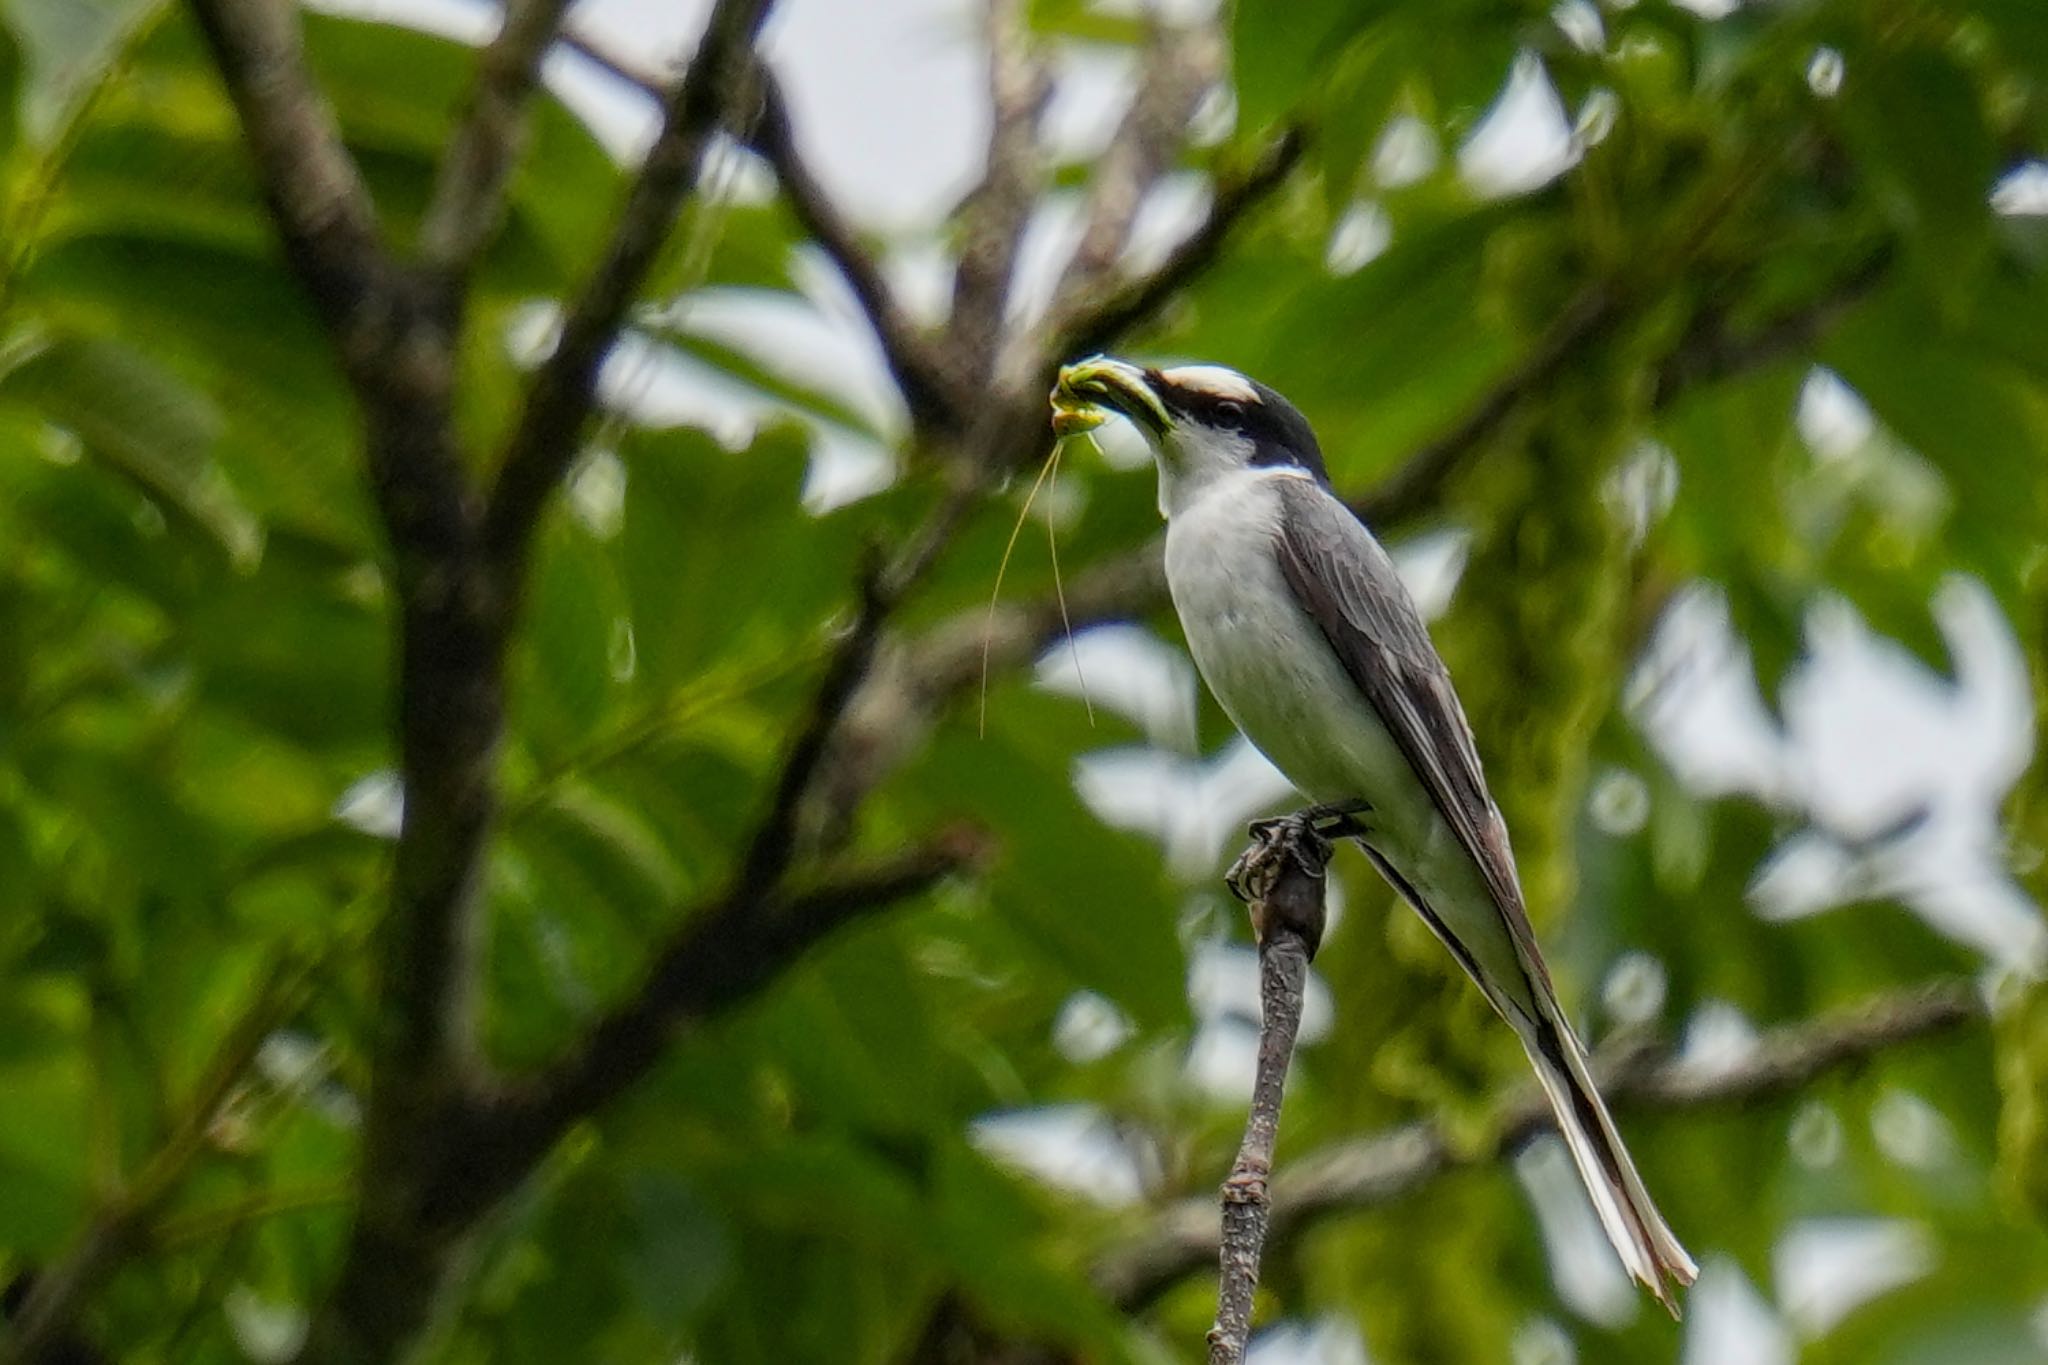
[1053,356,1698,1318]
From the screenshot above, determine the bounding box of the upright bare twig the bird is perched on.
[1208,819,1329,1365]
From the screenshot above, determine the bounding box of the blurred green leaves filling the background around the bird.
[0,0,2048,1365]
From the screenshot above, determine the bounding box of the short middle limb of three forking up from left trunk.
[420,0,573,282]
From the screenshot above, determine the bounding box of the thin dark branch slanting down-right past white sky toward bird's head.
[750,63,961,432]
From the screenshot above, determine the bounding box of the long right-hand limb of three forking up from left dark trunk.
[483,0,772,581]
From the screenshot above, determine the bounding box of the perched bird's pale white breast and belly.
[1165,469,1440,845]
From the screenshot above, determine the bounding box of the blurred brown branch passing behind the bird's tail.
[1094,980,1987,1310]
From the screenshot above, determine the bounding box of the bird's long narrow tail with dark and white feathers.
[1516,1007,1700,1318]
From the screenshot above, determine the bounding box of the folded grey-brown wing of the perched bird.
[1274,479,1550,986]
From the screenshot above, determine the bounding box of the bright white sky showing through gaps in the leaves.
[322,0,2048,1365]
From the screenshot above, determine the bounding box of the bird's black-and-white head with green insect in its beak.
[1053,356,1329,505]
